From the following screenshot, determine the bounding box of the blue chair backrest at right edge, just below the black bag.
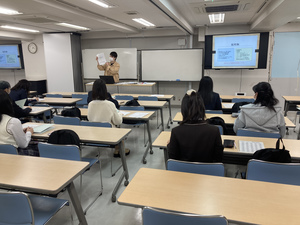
[247,159,300,185]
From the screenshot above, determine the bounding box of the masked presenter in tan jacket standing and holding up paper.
[96,52,120,83]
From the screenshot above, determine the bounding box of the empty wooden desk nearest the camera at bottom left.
[0,154,89,224]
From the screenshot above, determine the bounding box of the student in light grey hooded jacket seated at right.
[233,82,285,137]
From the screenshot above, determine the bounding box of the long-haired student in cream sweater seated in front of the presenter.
[87,79,130,157]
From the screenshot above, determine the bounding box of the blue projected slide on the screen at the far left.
[0,45,21,68]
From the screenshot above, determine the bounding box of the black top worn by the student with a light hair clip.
[168,122,224,162]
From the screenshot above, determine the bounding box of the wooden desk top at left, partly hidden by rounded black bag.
[26,123,131,145]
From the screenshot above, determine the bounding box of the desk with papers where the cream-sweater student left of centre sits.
[80,108,155,164]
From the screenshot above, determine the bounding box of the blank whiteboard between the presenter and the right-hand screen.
[141,49,203,81]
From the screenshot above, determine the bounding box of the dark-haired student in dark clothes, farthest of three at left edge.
[9,79,37,105]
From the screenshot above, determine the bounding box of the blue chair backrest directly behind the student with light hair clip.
[167,159,225,177]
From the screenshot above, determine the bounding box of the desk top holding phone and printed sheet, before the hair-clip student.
[152,131,300,158]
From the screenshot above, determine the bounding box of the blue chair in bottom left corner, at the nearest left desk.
[0,192,69,225]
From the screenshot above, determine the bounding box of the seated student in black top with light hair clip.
[168,90,223,162]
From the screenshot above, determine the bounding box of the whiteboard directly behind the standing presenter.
[82,48,137,79]
